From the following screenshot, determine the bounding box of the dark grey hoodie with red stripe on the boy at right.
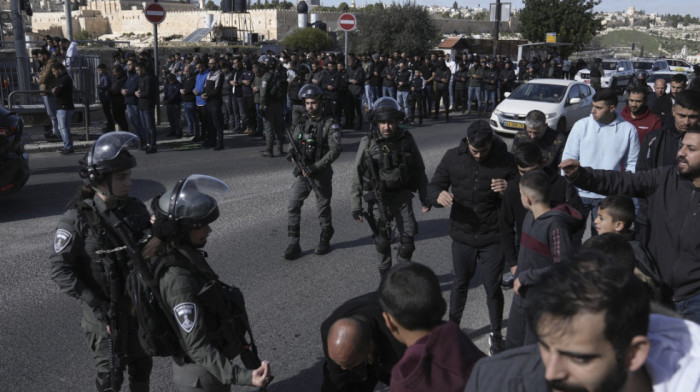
[515,204,582,287]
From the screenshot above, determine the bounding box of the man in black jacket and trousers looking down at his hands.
[428,120,517,354]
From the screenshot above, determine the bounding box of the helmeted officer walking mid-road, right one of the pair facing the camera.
[350,97,430,278]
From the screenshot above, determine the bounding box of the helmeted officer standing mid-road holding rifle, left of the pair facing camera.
[284,84,342,260]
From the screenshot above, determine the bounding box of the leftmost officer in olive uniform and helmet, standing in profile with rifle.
[49,131,153,391]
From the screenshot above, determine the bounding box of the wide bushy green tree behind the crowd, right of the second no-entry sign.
[352,3,440,55]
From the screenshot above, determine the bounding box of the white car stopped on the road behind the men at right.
[490,79,595,134]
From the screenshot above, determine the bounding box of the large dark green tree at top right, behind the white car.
[520,0,603,56]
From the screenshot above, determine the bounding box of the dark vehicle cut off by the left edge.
[0,106,29,196]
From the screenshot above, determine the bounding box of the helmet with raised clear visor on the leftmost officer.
[79,131,141,186]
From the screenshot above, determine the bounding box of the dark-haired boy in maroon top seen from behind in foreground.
[379,263,484,392]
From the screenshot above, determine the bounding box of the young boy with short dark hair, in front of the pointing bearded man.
[594,195,661,288]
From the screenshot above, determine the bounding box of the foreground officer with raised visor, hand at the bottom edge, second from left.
[144,174,270,392]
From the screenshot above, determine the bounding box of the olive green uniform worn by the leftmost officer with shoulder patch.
[49,195,152,391]
